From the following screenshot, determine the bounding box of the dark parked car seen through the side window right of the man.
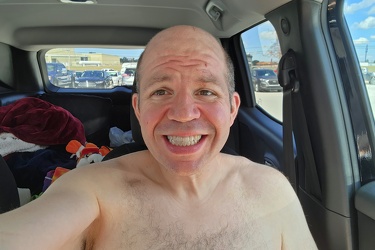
[252,68,283,92]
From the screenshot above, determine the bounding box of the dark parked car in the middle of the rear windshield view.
[75,70,112,88]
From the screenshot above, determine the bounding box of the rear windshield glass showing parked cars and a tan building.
[45,48,143,89]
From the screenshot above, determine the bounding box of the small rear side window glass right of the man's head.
[241,21,283,121]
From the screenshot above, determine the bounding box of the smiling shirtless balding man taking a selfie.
[0,26,316,250]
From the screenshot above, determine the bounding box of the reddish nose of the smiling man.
[168,93,200,122]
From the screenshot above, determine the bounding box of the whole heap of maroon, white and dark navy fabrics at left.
[0,97,86,195]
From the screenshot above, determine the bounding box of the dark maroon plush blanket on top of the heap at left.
[0,97,86,146]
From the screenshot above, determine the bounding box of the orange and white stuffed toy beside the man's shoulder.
[66,140,111,167]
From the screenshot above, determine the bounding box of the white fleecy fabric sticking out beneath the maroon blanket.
[0,133,46,157]
